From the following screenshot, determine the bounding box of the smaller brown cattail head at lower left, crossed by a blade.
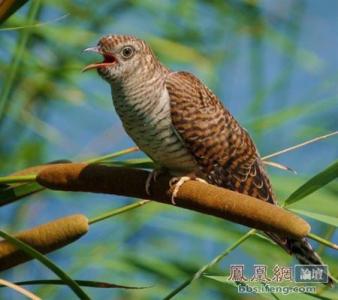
[0,215,88,271]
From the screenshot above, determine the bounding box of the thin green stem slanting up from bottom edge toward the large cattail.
[163,229,256,300]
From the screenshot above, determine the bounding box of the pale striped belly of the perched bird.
[114,90,196,175]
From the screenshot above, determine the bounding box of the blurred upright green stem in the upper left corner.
[0,0,41,120]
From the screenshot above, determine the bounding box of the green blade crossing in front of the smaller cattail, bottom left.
[0,230,90,300]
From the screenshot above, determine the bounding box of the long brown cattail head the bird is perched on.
[37,163,310,237]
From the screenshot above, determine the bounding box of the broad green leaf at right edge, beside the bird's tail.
[284,160,338,206]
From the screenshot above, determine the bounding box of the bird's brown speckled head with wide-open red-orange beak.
[83,35,155,83]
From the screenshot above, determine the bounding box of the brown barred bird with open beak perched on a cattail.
[83,34,334,285]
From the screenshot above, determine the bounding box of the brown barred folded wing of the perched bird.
[166,72,275,203]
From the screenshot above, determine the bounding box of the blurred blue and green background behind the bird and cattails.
[0,0,338,299]
